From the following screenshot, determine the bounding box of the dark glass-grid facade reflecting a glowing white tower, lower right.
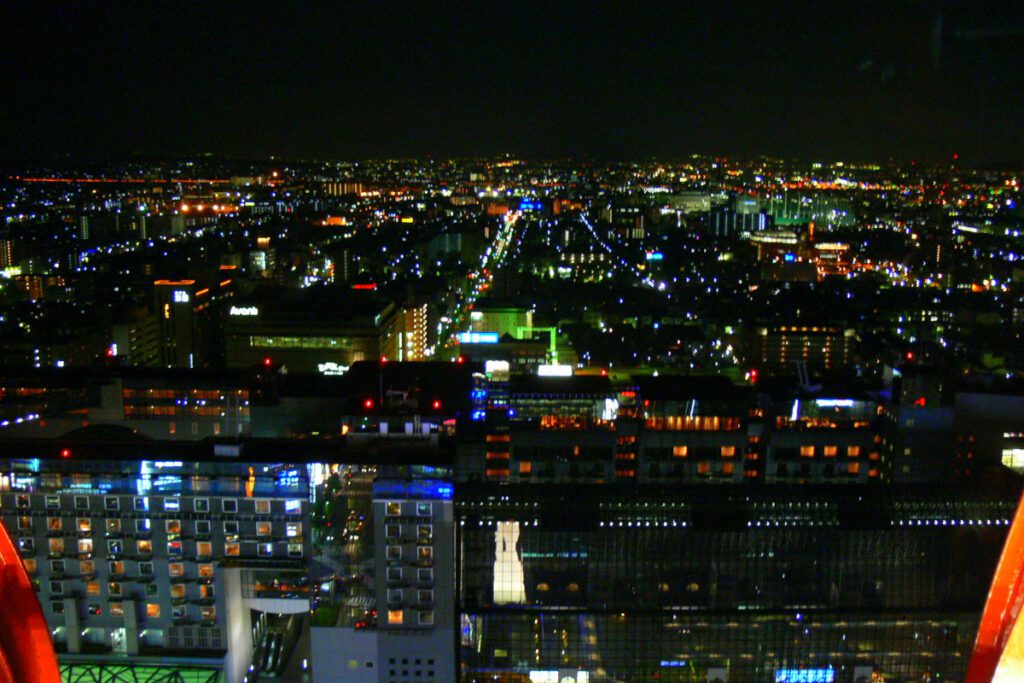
[457,485,1016,683]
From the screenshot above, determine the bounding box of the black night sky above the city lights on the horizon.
[0,0,1024,164]
